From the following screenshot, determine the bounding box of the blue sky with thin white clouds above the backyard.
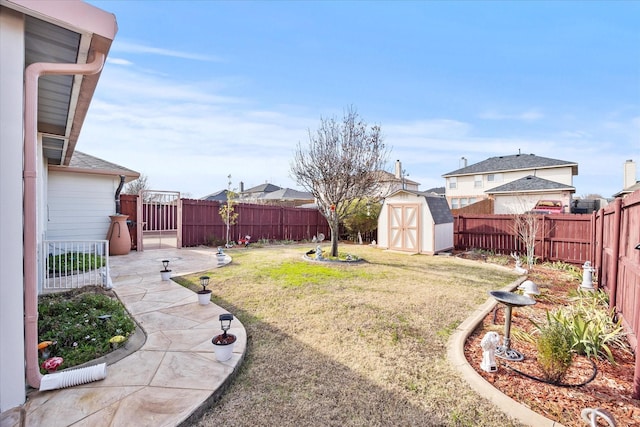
[82,1,640,198]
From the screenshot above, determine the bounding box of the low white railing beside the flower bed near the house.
[41,240,111,292]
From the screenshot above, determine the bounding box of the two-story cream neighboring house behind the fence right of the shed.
[442,154,578,214]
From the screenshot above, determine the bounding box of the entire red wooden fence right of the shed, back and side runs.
[454,196,640,399]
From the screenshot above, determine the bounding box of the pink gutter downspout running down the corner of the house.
[23,52,106,388]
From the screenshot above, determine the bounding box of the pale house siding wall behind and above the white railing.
[47,171,120,240]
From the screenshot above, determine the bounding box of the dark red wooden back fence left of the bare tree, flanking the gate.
[120,194,330,248]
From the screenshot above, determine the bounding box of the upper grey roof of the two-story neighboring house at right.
[442,154,578,178]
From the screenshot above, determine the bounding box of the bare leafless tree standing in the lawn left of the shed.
[291,107,388,256]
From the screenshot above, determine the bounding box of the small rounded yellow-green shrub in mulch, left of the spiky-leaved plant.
[536,321,573,384]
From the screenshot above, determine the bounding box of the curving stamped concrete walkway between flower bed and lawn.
[7,249,247,427]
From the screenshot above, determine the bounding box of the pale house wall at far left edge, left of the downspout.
[0,6,26,412]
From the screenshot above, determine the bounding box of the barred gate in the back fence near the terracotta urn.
[137,190,182,251]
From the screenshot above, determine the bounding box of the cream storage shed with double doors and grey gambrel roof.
[377,190,453,255]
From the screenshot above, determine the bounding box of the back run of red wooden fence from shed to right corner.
[453,214,595,265]
